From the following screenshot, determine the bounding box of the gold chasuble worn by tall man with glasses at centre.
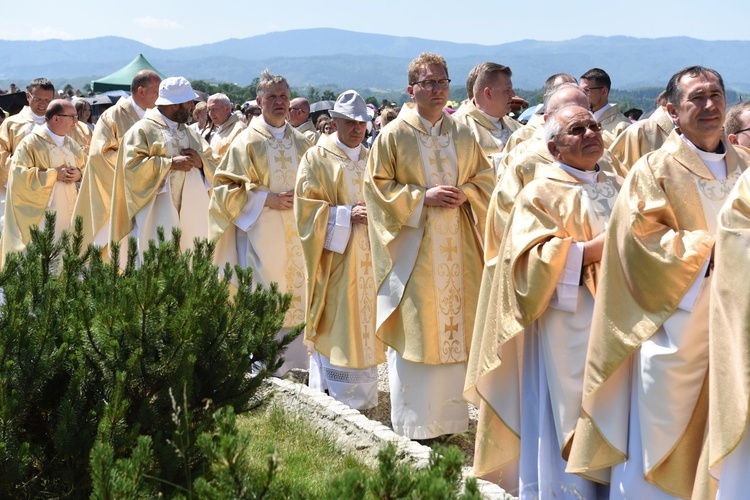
[364,104,493,364]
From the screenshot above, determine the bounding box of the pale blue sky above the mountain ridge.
[0,0,750,49]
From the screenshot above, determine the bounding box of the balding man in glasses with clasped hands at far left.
[1,99,86,266]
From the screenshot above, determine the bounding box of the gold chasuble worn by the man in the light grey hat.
[294,136,385,368]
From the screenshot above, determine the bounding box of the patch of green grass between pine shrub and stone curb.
[237,402,368,499]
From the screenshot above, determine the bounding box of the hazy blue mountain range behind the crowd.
[0,28,750,92]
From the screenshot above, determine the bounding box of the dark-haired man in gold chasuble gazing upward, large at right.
[568,66,748,498]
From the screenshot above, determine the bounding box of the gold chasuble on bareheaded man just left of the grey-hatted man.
[209,119,310,328]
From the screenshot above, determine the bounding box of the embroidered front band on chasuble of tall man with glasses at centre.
[418,134,466,363]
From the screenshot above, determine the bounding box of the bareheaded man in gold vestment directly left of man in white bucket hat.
[73,70,161,254]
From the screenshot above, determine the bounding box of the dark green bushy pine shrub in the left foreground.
[0,214,301,498]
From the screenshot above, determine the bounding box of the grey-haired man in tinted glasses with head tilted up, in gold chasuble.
[472,106,619,498]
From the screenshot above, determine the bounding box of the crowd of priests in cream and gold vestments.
[0,53,750,499]
